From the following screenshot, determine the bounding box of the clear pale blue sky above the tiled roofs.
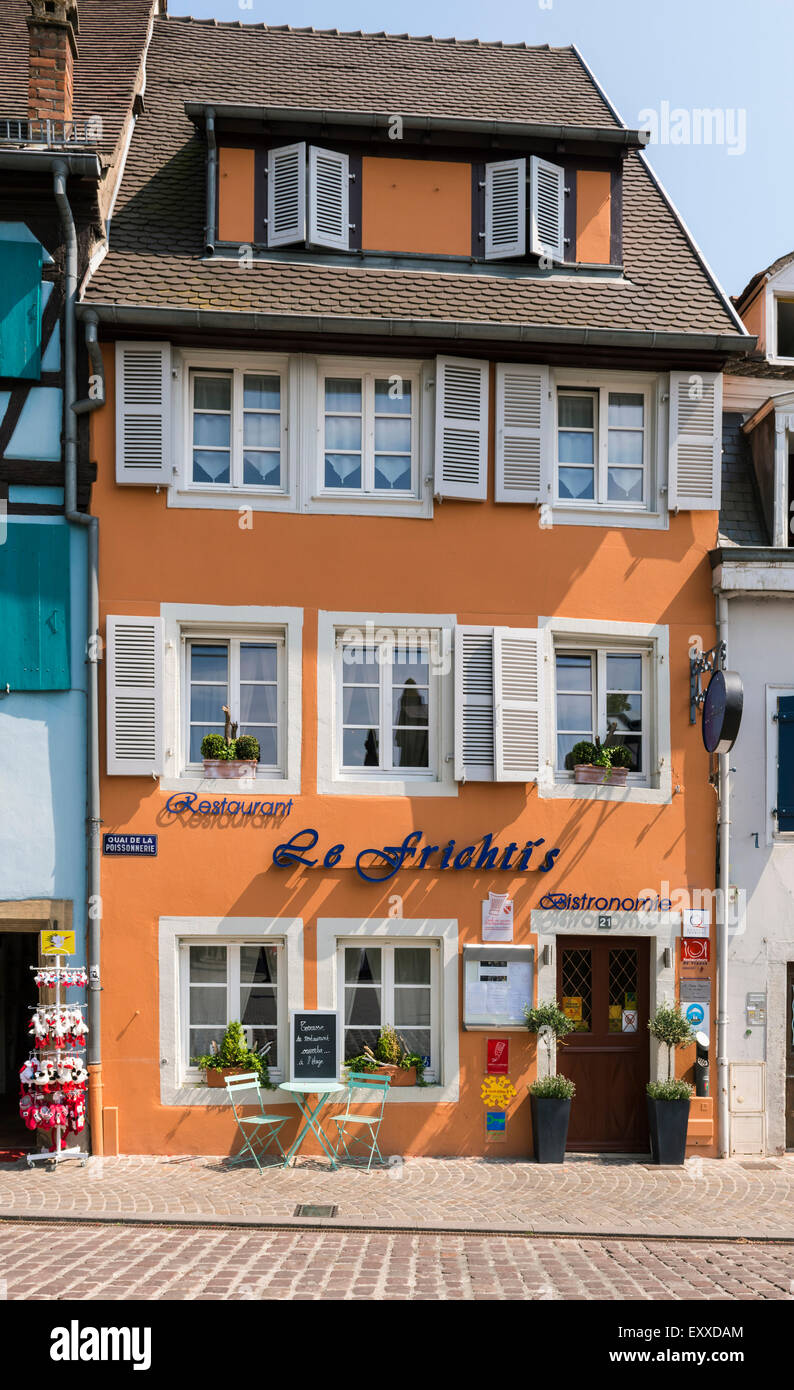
[168,0,794,293]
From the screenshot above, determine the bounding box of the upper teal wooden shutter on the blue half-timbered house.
[0,242,42,381]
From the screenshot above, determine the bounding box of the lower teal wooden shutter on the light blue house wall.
[0,521,70,691]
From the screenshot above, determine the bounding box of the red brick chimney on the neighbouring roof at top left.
[28,0,79,121]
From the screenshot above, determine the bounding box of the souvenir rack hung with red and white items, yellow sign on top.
[19,956,88,1166]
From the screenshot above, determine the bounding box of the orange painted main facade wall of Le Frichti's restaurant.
[92,348,716,1156]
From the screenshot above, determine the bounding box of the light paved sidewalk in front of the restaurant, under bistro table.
[0,1155,794,1240]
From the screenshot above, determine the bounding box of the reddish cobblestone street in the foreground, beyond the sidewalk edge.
[0,1222,794,1302]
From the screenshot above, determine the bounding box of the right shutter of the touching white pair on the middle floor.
[494,627,542,783]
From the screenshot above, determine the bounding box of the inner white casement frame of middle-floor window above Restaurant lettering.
[179,623,286,781]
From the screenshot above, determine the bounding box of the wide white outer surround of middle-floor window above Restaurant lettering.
[160,603,303,799]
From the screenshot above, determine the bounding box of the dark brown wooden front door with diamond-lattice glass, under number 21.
[556,935,651,1154]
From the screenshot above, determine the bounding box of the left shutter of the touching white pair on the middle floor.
[455,626,494,781]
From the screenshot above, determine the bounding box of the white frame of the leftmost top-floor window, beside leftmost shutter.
[171,349,295,507]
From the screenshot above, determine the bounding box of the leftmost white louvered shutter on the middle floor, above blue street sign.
[107,617,163,777]
